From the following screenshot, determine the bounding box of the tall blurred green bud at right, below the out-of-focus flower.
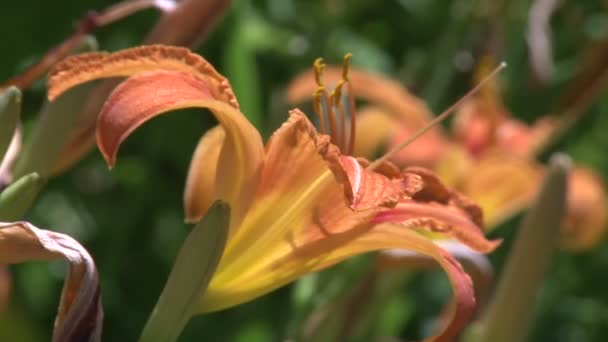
[466,154,570,342]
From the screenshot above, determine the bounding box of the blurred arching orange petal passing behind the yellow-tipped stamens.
[286,66,433,128]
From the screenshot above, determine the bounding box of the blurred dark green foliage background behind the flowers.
[0,0,608,342]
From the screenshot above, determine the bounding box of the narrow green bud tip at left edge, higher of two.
[0,87,21,162]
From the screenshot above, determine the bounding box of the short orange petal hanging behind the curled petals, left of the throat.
[184,126,226,222]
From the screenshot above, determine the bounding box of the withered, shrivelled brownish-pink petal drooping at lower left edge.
[0,222,103,342]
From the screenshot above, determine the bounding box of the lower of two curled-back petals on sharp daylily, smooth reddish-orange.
[97,71,264,226]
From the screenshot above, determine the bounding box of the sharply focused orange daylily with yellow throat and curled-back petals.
[49,45,499,341]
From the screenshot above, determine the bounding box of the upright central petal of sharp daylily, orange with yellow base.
[201,111,372,311]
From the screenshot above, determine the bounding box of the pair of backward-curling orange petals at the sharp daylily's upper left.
[49,45,263,226]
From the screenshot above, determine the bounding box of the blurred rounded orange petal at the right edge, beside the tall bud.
[560,168,608,250]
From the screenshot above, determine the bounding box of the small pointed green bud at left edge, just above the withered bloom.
[0,173,45,221]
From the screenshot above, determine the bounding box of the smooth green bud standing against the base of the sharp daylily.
[139,201,230,342]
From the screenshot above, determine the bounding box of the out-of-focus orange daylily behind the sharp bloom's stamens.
[287,59,607,249]
